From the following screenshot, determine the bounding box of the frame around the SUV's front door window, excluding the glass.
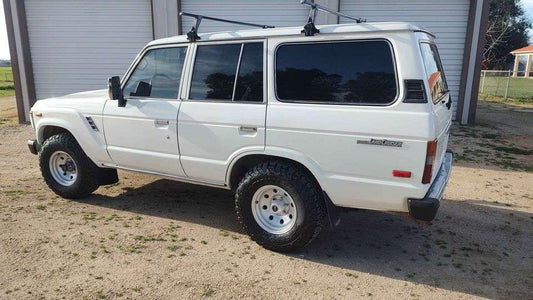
[120,43,191,101]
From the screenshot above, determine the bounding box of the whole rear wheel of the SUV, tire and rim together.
[235,161,326,252]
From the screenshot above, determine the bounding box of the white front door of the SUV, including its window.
[104,46,188,177]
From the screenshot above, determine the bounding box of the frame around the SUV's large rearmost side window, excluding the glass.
[272,37,396,107]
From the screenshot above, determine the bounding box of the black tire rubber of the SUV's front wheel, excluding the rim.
[39,133,100,199]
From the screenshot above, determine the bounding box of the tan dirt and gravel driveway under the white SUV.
[0,99,533,299]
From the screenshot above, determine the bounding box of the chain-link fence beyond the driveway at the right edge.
[479,70,533,100]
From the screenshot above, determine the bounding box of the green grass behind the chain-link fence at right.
[479,76,533,103]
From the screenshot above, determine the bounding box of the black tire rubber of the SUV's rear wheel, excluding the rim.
[235,161,327,252]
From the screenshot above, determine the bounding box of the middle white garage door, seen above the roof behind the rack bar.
[181,0,309,34]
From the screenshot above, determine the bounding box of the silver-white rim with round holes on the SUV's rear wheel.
[252,185,297,234]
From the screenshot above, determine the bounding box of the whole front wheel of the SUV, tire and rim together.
[39,133,100,199]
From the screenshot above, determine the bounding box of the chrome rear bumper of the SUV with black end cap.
[408,150,453,221]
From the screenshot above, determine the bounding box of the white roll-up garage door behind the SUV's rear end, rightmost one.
[340,0,470,115]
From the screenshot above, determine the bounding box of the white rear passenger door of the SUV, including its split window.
[178,41,266,184]
